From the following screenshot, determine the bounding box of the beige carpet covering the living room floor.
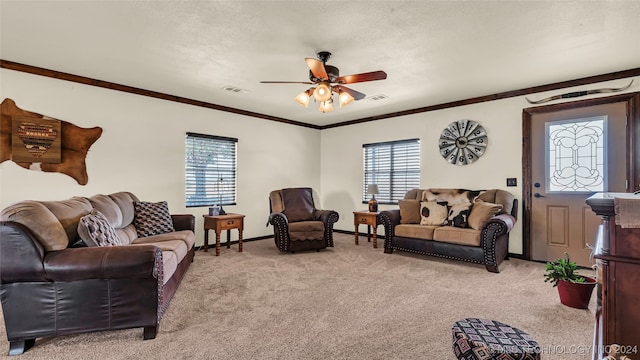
[0,234,595,360]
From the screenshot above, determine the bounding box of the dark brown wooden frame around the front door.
[514,92,640,260]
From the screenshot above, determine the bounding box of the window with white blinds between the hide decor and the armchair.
[185,133,238,207]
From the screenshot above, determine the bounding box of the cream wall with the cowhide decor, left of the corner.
[0,69,321,244]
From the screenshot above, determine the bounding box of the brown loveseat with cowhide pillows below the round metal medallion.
[379,189,518,273]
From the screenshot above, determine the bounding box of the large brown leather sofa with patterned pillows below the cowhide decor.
[0,192,195,355]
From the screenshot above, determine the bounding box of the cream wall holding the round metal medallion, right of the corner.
[321,79,640,254]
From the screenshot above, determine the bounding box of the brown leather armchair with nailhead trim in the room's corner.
[269,188,338,252]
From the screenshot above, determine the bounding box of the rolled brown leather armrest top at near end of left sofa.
[44,244,162,281]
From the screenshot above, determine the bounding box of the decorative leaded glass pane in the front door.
[545,116,607,193]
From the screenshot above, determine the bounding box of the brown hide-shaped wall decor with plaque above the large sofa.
[0,98,102,185]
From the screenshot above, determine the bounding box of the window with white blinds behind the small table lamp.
[362,139,420,204]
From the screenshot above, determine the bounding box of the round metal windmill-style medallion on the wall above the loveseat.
[439,120,489,165]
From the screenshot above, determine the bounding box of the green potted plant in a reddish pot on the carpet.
[544,252,596,309]
